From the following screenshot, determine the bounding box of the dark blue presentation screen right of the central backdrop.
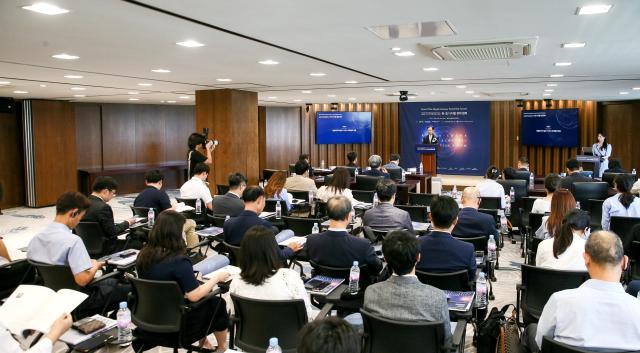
[521,108,578,147]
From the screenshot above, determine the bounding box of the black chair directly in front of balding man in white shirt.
[516,264,589,326]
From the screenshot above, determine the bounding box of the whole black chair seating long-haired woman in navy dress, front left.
[129,277,222,353]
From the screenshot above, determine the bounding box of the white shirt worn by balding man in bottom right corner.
[536,279,640,351]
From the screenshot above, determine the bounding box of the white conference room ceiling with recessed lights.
[0,0,640,105]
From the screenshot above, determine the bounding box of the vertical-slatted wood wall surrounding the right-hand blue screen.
[488,100,598,175]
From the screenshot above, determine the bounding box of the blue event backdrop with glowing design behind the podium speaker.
[400,102,491,175]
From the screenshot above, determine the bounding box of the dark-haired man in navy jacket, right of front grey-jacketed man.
[417,196,476,281]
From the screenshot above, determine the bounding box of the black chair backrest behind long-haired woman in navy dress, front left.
[130,277,185,333]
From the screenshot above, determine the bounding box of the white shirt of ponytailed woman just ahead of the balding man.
[536,233,587,271]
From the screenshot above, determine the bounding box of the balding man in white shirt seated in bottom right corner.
[523,231,640,351]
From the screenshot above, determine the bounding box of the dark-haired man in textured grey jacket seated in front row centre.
[364,230,451,344]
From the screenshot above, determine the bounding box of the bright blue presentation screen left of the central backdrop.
[316,112,371,144]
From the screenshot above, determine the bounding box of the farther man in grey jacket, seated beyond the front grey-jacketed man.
[362,180,413,232]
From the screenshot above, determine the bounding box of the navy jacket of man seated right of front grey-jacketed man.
[416,231,476,280]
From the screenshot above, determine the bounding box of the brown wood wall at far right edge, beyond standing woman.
[594,101,640,171]
